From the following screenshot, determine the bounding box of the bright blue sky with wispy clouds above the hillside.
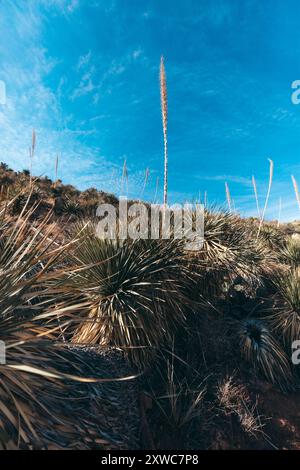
[0,0,300,220]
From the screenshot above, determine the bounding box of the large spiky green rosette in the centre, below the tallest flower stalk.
[55,232,188,368]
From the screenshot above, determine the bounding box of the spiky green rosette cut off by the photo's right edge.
[272,268,300,347]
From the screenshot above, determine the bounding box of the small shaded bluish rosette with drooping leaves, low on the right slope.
[239,318,292,390]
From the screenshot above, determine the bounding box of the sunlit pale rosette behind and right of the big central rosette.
[186,210,273,298]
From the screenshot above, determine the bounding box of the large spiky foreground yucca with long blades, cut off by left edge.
[0,202,138,449]
